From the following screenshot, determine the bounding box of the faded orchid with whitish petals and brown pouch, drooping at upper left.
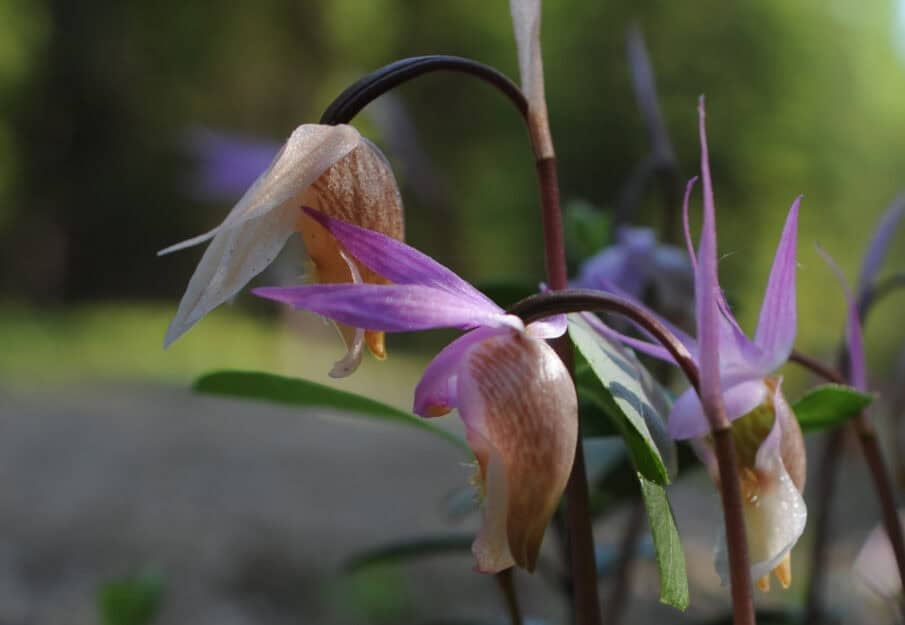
[159,124,403,377]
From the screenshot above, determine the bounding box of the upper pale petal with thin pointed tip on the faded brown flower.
[158,124,361,255]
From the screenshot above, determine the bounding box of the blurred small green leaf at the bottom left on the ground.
[95,572,163,625]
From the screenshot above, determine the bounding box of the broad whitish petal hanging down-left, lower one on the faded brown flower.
[164,206,298,348]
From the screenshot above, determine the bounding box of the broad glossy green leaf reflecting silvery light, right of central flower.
[569,315,676,485]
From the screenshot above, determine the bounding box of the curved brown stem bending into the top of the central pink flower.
[508,289,699,390]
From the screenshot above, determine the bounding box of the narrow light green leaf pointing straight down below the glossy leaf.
[638,473,688,611]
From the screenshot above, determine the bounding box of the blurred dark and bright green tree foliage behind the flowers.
[0,0,905,356]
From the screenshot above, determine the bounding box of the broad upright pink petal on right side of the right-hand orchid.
[754,196,802,373]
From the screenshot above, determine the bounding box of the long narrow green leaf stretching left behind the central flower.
[192,371,468,450]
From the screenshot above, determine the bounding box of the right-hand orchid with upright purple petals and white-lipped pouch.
[595,98,807,590]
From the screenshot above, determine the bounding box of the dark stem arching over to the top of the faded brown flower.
[320,54,528,125]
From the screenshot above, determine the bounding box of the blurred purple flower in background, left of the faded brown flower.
[188,128,280,200]
